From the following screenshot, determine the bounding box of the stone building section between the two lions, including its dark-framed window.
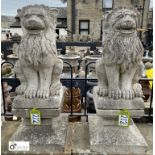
[67,0,103,40]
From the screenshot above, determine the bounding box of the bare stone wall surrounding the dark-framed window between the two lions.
[67,0,103,40]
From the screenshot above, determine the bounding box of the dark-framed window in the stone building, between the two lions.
[79,20,89,35]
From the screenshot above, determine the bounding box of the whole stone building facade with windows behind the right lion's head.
[67,0,150,41]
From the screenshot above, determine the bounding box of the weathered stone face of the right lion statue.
[109,9,137,34]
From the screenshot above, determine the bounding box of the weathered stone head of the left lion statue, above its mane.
[19,5,56,34]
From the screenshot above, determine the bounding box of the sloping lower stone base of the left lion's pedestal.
[10,115,68,154]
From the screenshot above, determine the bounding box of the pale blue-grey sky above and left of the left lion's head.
[1,0,67,16]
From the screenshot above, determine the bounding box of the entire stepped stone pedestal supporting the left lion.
[10,90,68,154]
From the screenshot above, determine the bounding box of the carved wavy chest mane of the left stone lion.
[18,34,57,66]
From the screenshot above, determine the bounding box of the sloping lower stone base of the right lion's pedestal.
[89,116,147,155]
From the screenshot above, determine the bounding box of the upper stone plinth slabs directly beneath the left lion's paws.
[12,88,63,126]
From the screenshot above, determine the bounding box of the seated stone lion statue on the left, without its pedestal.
[15,5,63,98]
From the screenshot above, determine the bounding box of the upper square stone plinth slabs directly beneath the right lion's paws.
[93,87,144,117]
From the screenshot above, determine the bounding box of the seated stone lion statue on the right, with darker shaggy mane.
[96,8,144,99]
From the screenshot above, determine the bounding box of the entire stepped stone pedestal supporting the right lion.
[89,87,147,155]
